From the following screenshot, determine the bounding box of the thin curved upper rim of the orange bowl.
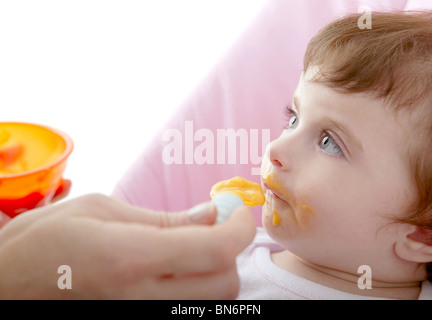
[0,121,74,180]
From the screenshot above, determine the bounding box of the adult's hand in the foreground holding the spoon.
[0,195,255,299]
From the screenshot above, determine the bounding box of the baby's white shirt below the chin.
[237,228,432,300]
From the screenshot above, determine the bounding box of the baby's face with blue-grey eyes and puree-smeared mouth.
[262,71,415,280]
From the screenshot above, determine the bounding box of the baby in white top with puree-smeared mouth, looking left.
[238,12,432,299]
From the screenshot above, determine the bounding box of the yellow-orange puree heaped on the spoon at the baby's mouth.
[210,177,266,207]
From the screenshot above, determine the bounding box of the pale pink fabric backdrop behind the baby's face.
[113,0,430,225]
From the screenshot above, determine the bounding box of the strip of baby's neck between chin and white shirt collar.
[271,250,421,300]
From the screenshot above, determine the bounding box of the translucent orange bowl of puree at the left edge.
[0,122,73,218]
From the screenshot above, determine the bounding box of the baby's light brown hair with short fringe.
[304,10,432,279]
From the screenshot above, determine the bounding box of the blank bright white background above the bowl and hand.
[0,0,266,198]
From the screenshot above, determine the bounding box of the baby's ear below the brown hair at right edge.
[395,224,432,263]
